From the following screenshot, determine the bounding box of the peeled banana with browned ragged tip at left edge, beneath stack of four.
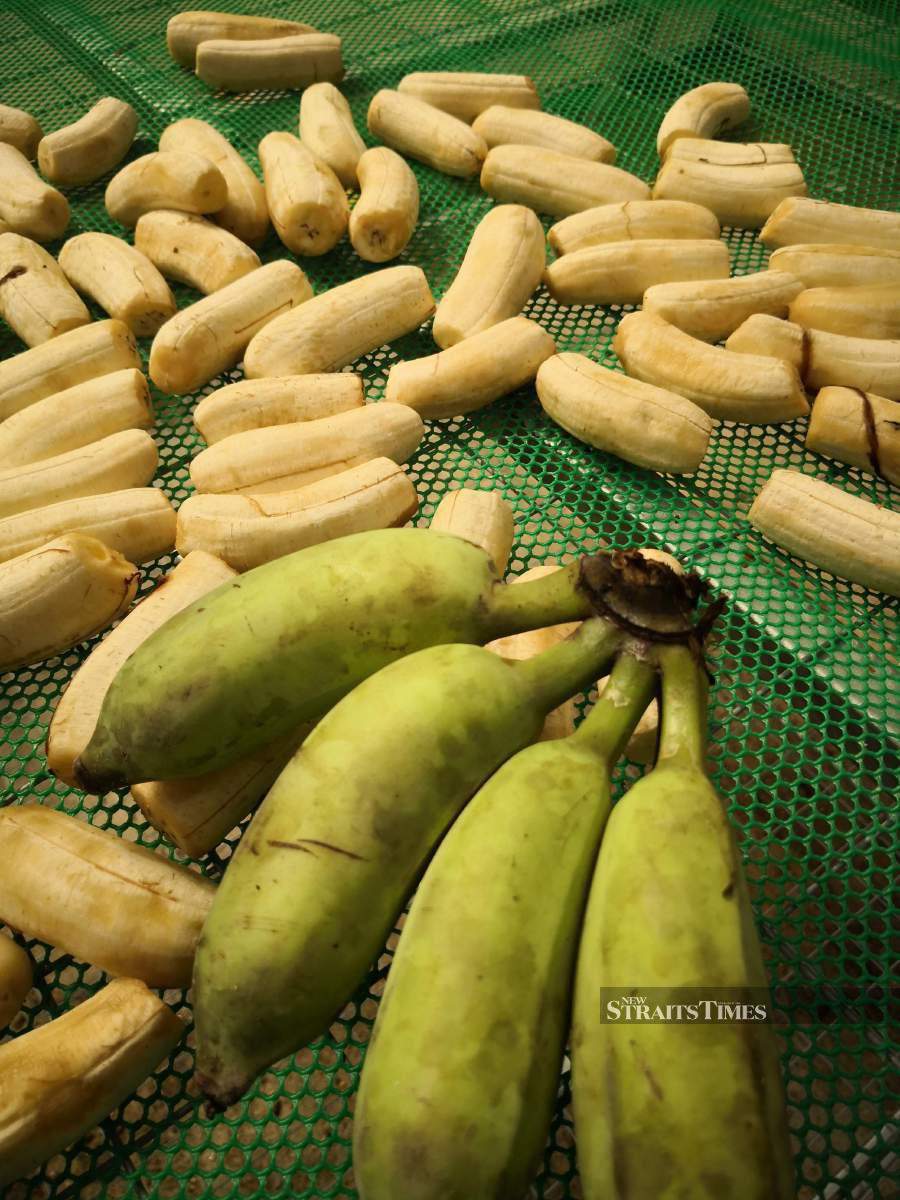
[0,533,140,676]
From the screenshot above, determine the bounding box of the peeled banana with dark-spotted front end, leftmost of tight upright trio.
[259,132,350,256]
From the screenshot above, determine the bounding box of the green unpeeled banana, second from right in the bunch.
[353,654,655,1200]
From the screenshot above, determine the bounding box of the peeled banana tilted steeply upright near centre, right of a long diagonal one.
[432,204,546,349]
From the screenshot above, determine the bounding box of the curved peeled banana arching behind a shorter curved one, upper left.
[160,118,269,246]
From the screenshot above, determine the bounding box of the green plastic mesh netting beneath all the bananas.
[0,0,900,1200]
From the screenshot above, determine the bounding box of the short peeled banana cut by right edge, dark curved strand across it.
[806,388,900,486]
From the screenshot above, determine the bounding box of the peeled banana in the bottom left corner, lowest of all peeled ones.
[0,979,185,1186]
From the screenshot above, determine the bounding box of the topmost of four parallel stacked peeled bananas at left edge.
[0,320,140,421]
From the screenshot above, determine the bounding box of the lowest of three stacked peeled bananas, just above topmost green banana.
[176,458,419,571]
